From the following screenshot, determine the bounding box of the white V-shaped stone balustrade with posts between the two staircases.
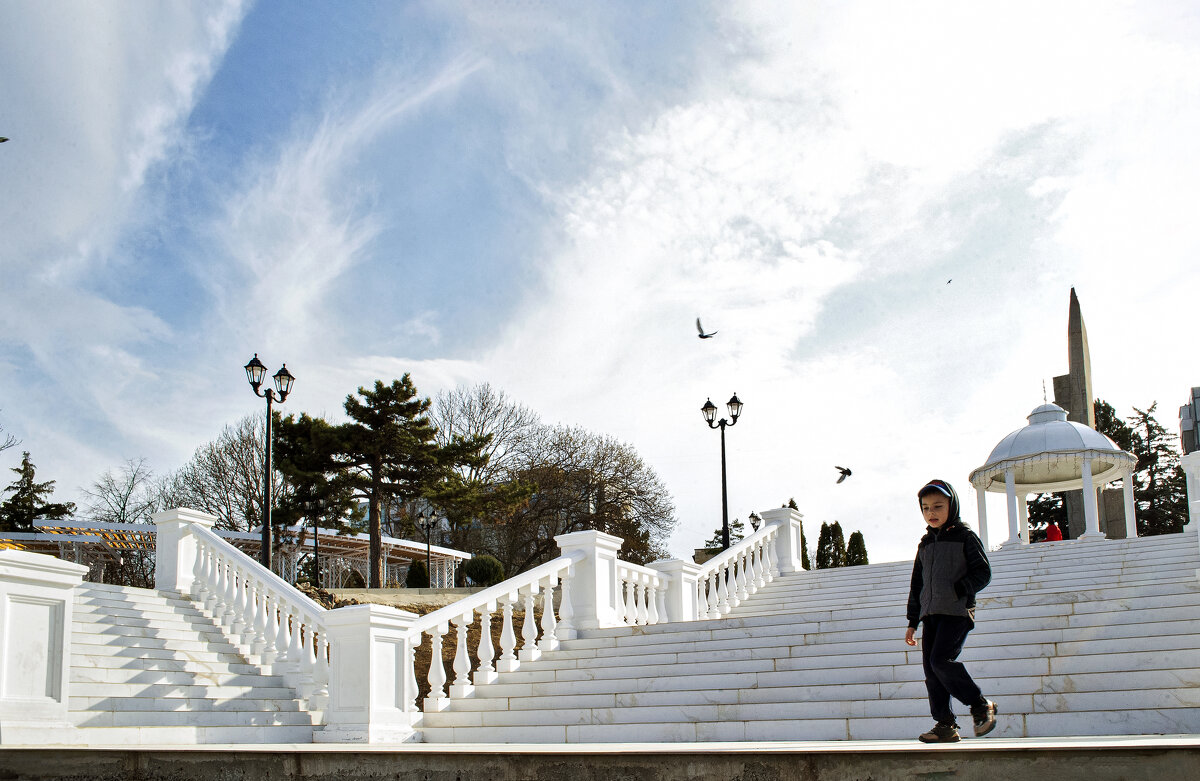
[147,510,800,743]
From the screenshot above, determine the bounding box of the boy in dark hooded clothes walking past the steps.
[904,480,996,743]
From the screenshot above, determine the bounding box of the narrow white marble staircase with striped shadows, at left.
[70,583,313,745]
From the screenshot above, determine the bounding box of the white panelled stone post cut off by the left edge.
[0,551,88,745]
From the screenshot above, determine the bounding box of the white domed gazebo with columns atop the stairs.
[971,403,1138,547]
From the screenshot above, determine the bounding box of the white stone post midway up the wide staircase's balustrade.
[554,530,625,630]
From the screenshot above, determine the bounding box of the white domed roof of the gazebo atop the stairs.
[971,403,1136,491]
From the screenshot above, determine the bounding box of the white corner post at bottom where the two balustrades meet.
[313,605,420,743]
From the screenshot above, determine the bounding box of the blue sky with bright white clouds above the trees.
[0,0,1200,560]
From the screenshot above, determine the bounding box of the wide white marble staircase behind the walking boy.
[420,533,1200,743]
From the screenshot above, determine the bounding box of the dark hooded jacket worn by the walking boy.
[907,481,991,627]
